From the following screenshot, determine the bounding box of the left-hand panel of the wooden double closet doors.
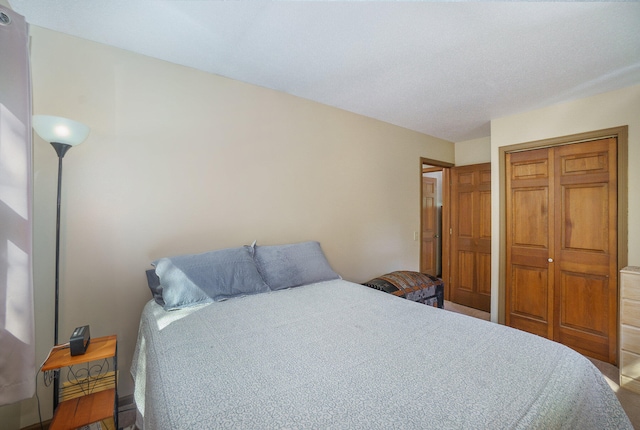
[505,149,555,339]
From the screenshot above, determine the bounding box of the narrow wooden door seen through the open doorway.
[420,176,439,276]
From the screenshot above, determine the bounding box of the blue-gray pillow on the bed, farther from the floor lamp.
[247,242,341,291]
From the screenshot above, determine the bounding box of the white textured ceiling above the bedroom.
[9,0,640,141]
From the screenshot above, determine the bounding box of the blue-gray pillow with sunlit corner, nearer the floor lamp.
[151,247,269,310]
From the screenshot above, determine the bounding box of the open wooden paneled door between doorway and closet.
[449,163,491,312]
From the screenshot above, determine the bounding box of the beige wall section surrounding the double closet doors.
[491,85,640,321]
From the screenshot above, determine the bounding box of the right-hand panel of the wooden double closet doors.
[553,138,618,363]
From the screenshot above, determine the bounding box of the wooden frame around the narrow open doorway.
[418,157,455,300]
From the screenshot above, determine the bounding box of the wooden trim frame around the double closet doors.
[498,125,629,324]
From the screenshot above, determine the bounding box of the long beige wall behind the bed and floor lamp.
[5,27,454,426]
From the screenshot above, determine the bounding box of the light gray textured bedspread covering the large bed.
[131,280,632,430]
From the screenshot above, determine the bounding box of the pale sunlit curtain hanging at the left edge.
[0,6,36,405]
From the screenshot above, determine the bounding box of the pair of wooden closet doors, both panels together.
[506,138,618,364]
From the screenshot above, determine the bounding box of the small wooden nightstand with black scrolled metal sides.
[42,335,118,430]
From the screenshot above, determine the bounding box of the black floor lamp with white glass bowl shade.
[32,115,89,410]
